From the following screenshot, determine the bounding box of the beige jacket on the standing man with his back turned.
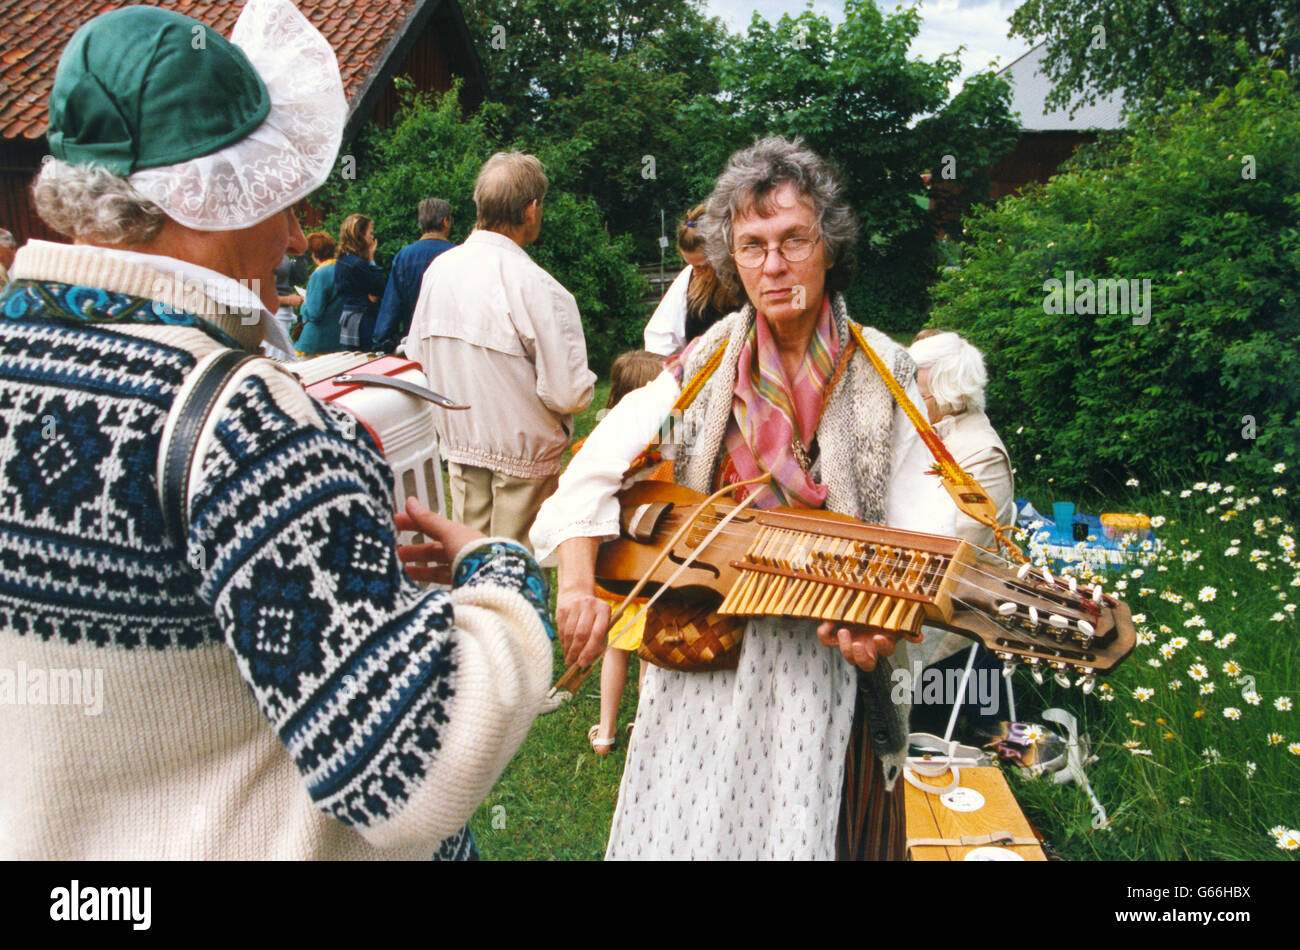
[406,231,595,478]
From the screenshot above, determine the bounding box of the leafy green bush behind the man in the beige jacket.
[310,84,646,373]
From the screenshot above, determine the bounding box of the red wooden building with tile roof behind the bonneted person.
[0,0,488,243]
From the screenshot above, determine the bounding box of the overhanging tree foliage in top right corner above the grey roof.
[1011,0,1300,114]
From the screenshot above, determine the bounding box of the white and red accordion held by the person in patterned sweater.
[285,352,465,543]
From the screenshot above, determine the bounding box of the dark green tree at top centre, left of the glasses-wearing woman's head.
[469,0,729,250]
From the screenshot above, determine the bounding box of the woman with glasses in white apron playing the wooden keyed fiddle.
[532,138,954,859]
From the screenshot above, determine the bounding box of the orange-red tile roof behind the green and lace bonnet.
[0,0,426,139]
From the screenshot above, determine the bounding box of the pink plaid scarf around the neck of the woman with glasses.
[718,296,840,508]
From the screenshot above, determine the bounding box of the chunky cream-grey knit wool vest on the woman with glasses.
[675,294,917,524]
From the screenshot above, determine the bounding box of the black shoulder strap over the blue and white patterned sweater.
[159,350,257,551]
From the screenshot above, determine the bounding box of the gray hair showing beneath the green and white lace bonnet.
[31,156,166,246]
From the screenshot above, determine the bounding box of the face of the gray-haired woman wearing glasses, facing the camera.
[732,183,831,325]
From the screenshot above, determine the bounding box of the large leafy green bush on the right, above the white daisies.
[931,66,1300,498]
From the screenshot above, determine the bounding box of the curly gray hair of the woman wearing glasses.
[701,136,858,296]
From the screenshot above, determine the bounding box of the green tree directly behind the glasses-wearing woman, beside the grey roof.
[723,0,1017,330]
